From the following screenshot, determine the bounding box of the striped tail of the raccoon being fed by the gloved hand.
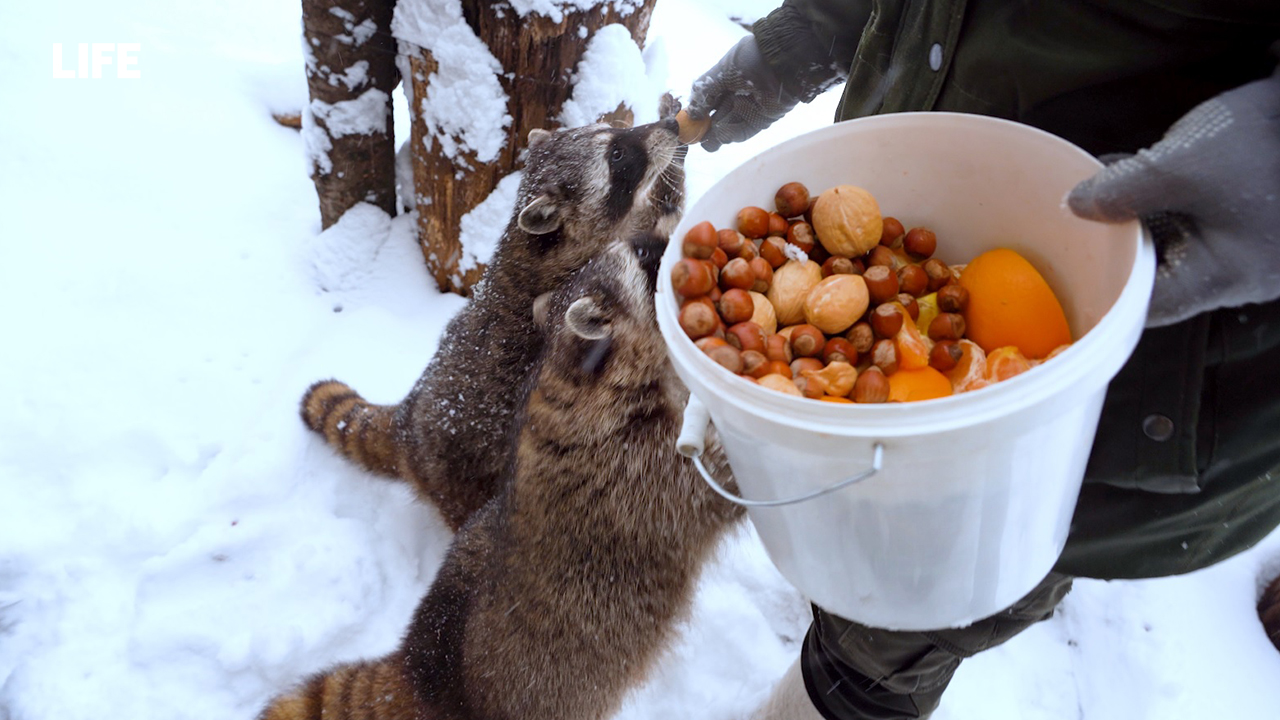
[302,380,399,478]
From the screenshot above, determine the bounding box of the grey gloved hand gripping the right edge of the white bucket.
[1068,72,1280,327]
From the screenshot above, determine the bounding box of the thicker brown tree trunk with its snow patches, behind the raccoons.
[393,0,655,295]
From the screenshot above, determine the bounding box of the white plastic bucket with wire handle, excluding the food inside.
[657,113,1155,630]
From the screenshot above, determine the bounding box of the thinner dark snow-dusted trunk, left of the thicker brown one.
[302,0,399,228]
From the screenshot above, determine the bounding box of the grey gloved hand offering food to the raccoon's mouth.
[689,35,799,152]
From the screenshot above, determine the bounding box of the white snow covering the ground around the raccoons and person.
[0,0,1280,720]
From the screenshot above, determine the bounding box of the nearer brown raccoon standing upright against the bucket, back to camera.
[261,240,742,720]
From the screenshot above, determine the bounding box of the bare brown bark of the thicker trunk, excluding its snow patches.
[399,0,655,295]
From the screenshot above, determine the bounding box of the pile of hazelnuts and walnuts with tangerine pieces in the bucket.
[671,182,1059,402]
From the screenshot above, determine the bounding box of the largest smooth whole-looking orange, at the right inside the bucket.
[960,247,1071,357]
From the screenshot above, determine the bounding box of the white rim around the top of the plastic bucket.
[655,113,1156,438]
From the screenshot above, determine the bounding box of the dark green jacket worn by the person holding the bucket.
[754,0,1280,578]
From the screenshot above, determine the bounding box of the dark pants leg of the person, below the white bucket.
[800,573,1071,720]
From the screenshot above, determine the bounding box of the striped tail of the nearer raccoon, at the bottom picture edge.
[257,656,426,720]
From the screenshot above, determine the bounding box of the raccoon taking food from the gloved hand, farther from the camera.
[301,117,685,529]
